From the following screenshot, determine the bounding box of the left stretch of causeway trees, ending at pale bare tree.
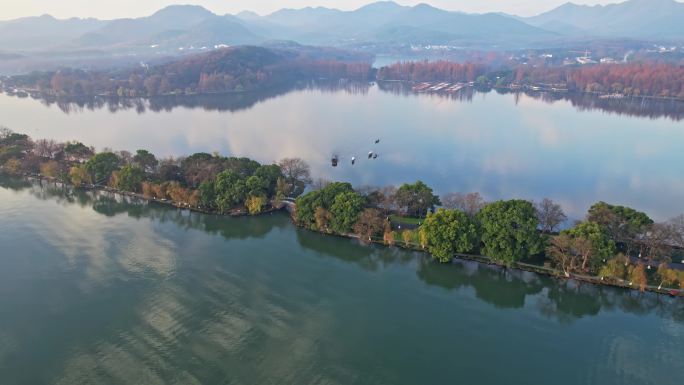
[0,129,310,214]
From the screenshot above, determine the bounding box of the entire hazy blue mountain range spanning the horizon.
[0,0,684,54]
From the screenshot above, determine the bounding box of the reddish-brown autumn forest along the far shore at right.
[377,61,684,98]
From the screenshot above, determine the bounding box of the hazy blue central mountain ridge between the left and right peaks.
[238,2,556,44]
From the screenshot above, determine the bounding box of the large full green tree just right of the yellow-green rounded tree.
[477,200,544,264]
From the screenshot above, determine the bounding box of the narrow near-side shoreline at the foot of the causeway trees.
[5,173,684,298]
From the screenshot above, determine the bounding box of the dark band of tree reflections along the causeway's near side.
[5,177,684,322]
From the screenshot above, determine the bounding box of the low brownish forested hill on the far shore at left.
[4,45,371,97]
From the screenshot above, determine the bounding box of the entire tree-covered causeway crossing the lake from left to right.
[0,128,684,295]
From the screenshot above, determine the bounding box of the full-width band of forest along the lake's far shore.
[0,46,684,99]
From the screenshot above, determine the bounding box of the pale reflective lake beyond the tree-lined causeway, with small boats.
[0,84,684,220]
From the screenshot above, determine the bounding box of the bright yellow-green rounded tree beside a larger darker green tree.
[420,209,479,262]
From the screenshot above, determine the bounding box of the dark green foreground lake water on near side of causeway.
[0,177,684,385]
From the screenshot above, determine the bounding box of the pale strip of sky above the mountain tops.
[0,0,623,20]
